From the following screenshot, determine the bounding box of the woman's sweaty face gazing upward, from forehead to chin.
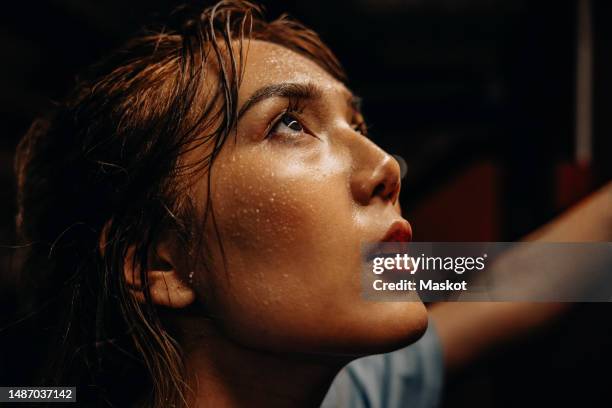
[193,41,427,355]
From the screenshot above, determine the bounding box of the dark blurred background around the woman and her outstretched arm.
[0,0,612,407]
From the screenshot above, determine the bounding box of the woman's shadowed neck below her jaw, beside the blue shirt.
[177,320,348,408]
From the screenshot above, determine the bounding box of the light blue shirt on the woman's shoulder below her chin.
[321,319,444,408]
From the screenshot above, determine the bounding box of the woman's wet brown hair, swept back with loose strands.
[15,1,344,407]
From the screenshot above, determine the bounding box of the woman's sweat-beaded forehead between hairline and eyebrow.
[239,40,350,102]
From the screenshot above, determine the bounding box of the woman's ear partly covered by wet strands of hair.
[123,244,195,309]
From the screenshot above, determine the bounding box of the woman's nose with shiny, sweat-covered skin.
[350,137,401,205]
